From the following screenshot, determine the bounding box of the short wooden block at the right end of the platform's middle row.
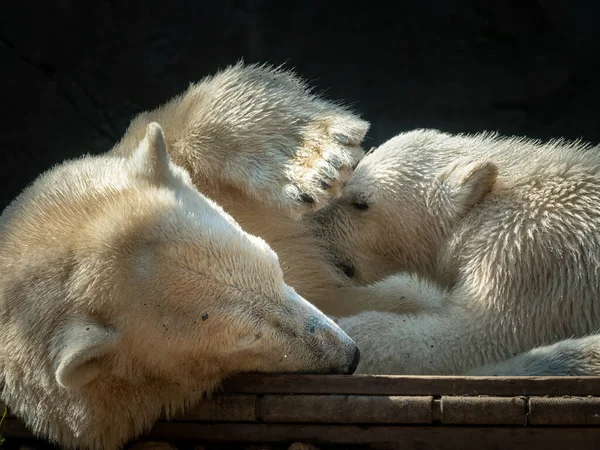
[529,397,600,425]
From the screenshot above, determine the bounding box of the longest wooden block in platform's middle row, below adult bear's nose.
[261,395,433,424]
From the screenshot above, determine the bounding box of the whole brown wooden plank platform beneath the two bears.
[0,375,600,450]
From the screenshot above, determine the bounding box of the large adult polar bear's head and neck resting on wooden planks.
[0,123,359,450]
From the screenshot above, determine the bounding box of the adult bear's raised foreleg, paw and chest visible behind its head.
[112,63,427,316]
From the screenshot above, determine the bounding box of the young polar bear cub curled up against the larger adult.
[316,130,600,375]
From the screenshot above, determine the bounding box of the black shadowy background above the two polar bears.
[0,0,600,209]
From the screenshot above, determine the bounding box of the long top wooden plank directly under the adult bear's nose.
[223,374,600,396]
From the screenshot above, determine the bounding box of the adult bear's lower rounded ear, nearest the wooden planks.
[51,320,118,389]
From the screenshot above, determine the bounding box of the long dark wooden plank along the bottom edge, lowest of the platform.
[146,422,600,450]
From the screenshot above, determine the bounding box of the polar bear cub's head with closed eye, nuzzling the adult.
[314,130,498,283]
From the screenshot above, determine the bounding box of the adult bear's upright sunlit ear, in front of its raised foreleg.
[133,122,171,184]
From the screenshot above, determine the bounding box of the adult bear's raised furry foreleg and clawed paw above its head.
[114,63,369,216]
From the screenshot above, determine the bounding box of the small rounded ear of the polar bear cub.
[437,158,498,217]
